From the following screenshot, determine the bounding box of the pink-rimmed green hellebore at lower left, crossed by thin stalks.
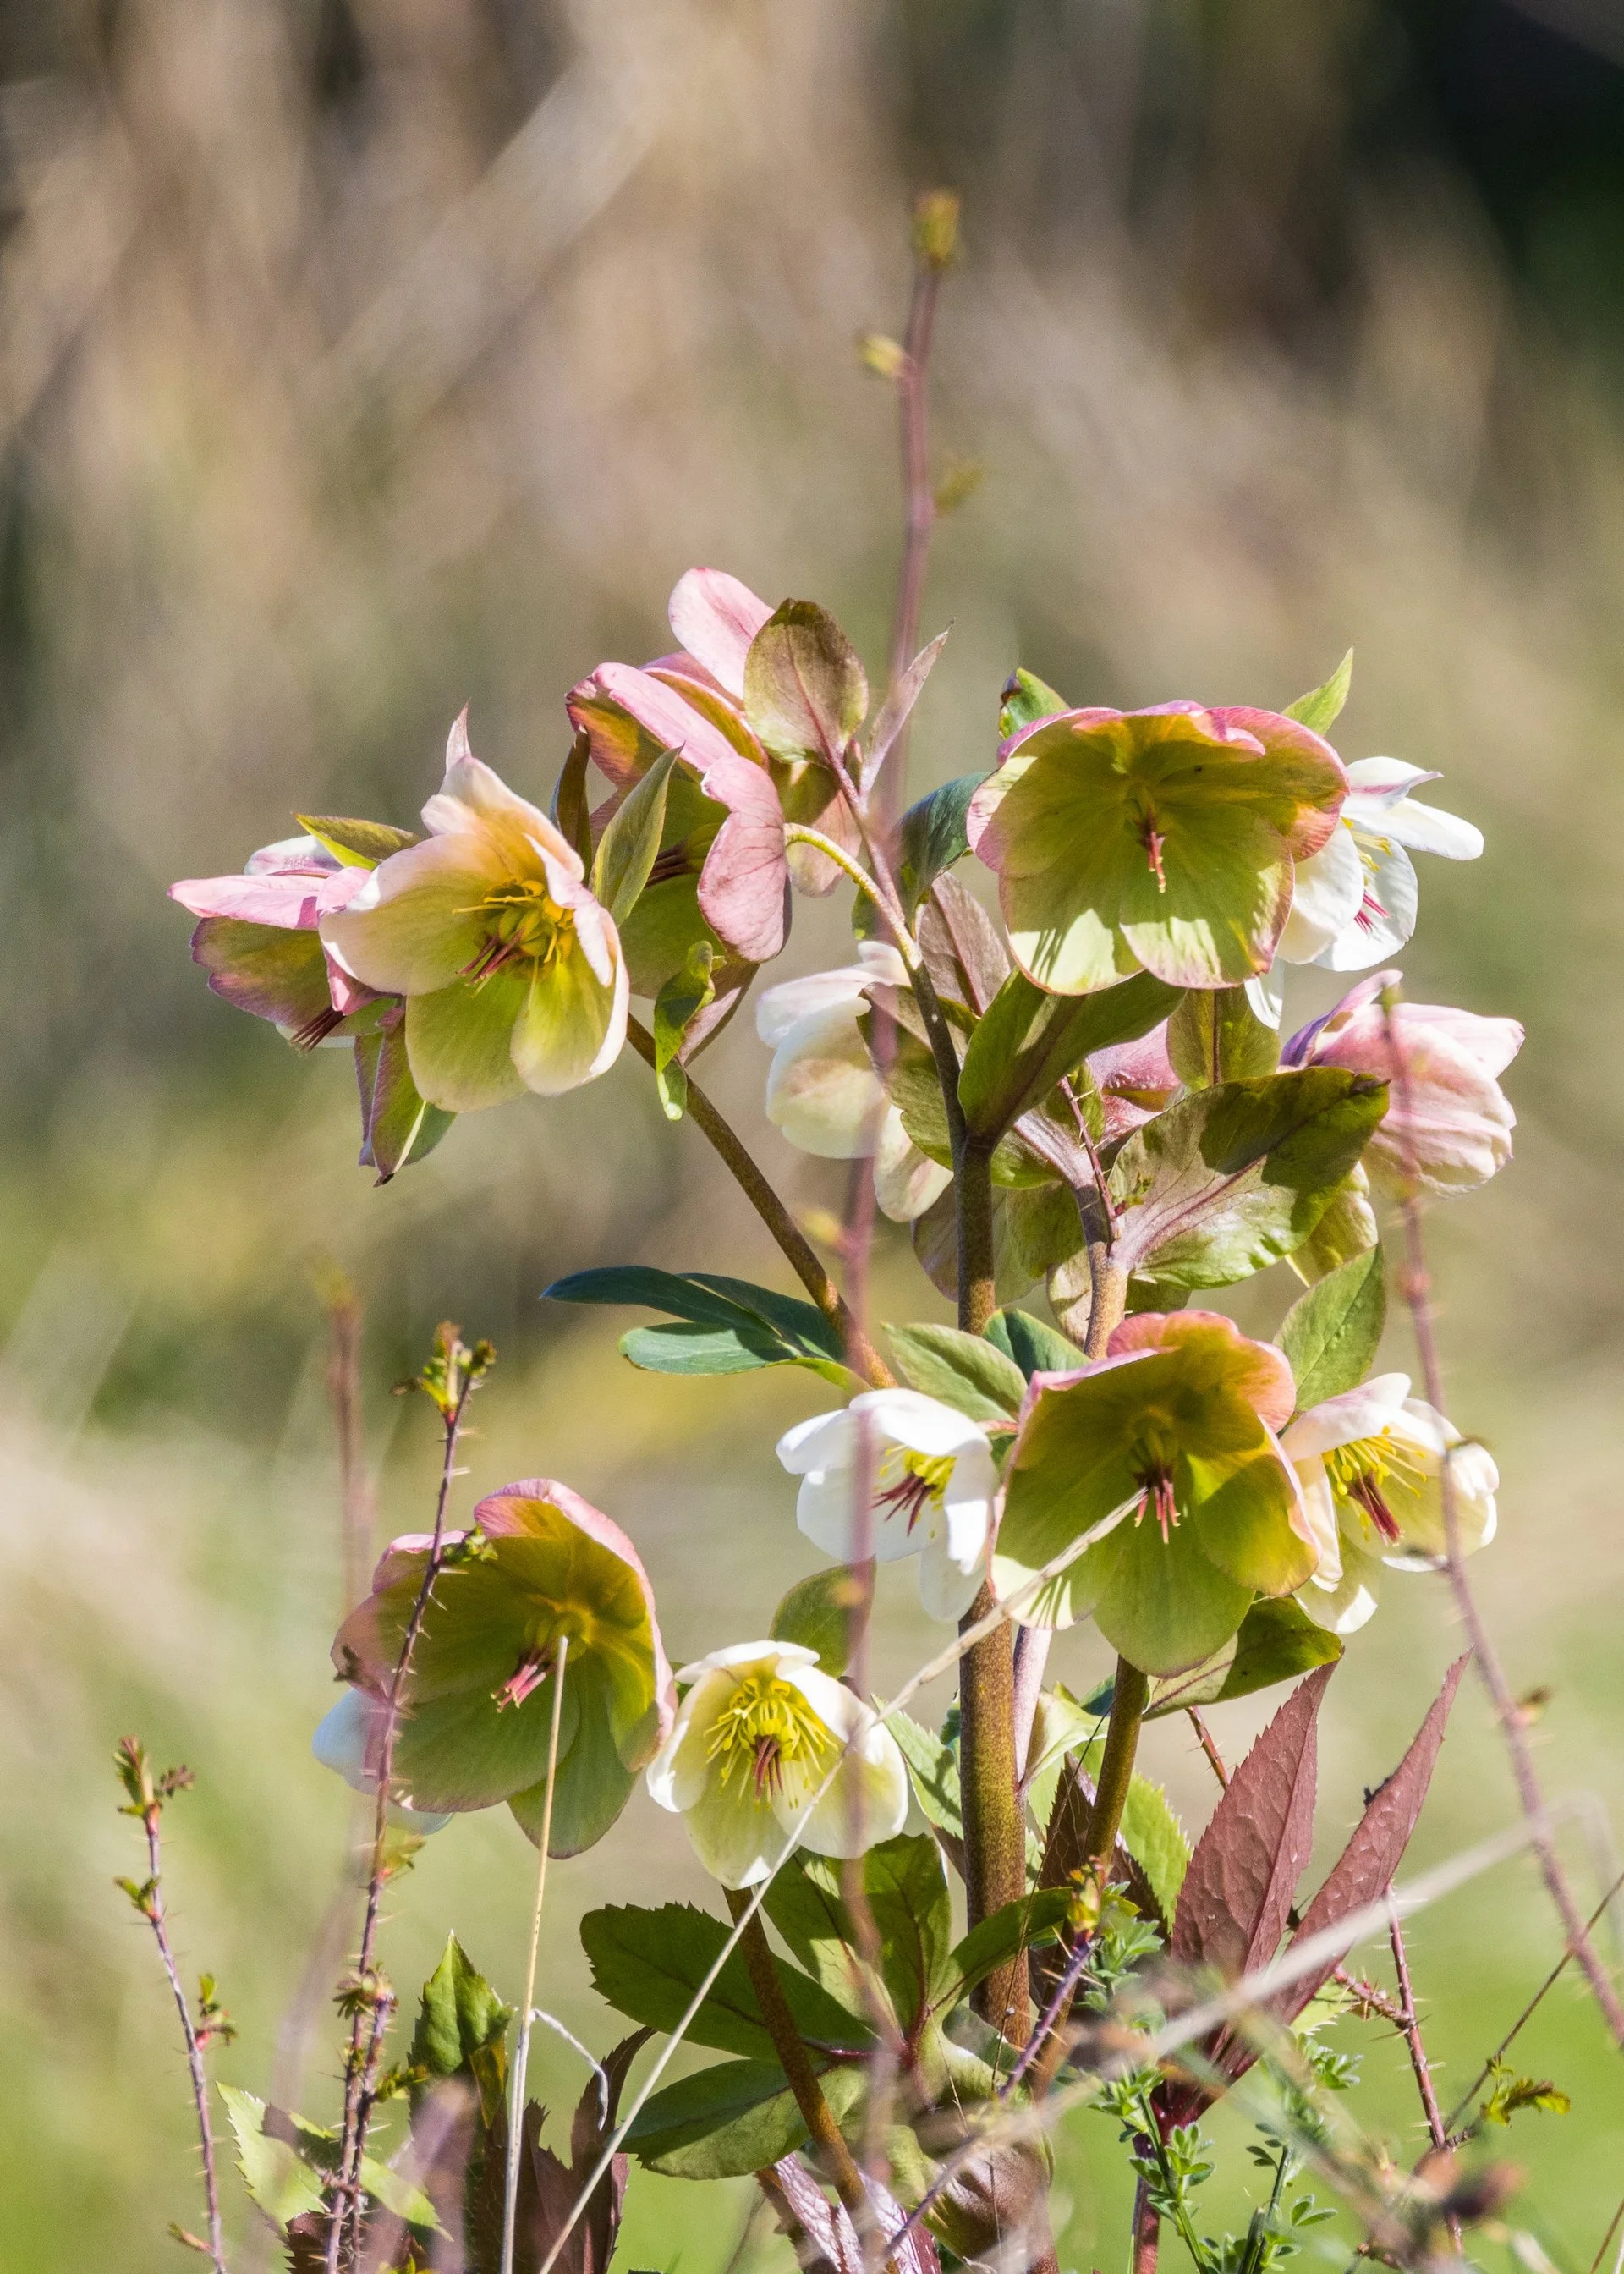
[332,1478,676,1855]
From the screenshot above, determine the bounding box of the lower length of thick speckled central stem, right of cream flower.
[957,1587,1030,2045]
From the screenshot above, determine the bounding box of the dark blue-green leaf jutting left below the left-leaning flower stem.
[544,1265,851,1389]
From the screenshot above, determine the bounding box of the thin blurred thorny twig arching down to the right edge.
[1380,987,1624,2052]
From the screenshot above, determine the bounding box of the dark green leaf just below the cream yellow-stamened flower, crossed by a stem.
[580,1903,871,2060]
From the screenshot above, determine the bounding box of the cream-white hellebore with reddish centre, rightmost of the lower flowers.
[1281,1374,1499,1635]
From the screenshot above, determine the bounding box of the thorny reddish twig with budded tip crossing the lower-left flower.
[326,1326,496,2274]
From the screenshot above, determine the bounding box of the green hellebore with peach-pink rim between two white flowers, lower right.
[991,1310,1320,1673]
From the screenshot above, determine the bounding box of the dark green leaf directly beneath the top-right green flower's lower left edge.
[957,971,1181,1144]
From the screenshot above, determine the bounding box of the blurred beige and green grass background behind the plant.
[0,0,1624,2274]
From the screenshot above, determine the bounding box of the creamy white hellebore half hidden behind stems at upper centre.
[755,939,953,1223]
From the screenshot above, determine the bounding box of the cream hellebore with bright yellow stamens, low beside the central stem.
[646,1642,908,1887]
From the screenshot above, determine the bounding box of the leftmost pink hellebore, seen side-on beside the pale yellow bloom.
[168,837,376,1051]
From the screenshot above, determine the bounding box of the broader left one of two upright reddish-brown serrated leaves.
[1171,1667,1335,1979]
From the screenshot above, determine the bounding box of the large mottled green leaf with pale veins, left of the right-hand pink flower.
[1110,1067,1387,1287]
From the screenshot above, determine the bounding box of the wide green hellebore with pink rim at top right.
[967,703,1347,994]
